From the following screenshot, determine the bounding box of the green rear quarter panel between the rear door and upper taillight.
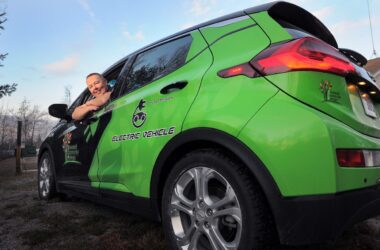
[183,19,278,136]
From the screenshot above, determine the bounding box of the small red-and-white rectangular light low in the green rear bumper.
[336,149,380,167]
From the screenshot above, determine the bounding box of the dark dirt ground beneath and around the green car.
[0,158,380,250]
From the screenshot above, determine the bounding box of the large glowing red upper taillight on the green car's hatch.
[250,37,355,76]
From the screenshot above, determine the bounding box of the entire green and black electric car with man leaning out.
[38,2,380,249]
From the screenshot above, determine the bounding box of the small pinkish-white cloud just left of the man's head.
[43,54,80,75]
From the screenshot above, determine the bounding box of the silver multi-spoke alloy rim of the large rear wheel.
[169,166,242,249]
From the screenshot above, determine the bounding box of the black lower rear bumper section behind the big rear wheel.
[272,185,380,245]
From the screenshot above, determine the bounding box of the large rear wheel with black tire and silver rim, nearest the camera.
[162,149,277,250]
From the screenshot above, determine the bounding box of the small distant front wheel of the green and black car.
[37,152,56,200]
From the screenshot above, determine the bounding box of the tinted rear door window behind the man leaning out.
[126,36,192,92]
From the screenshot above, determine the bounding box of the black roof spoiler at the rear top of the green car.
[244,1,338,49]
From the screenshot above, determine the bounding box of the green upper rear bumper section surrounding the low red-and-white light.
[239,92,380,197]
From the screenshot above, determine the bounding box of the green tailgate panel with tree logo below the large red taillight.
[268,72,380,137]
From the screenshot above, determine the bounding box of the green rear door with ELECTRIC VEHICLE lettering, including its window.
[94,31,212,197]
